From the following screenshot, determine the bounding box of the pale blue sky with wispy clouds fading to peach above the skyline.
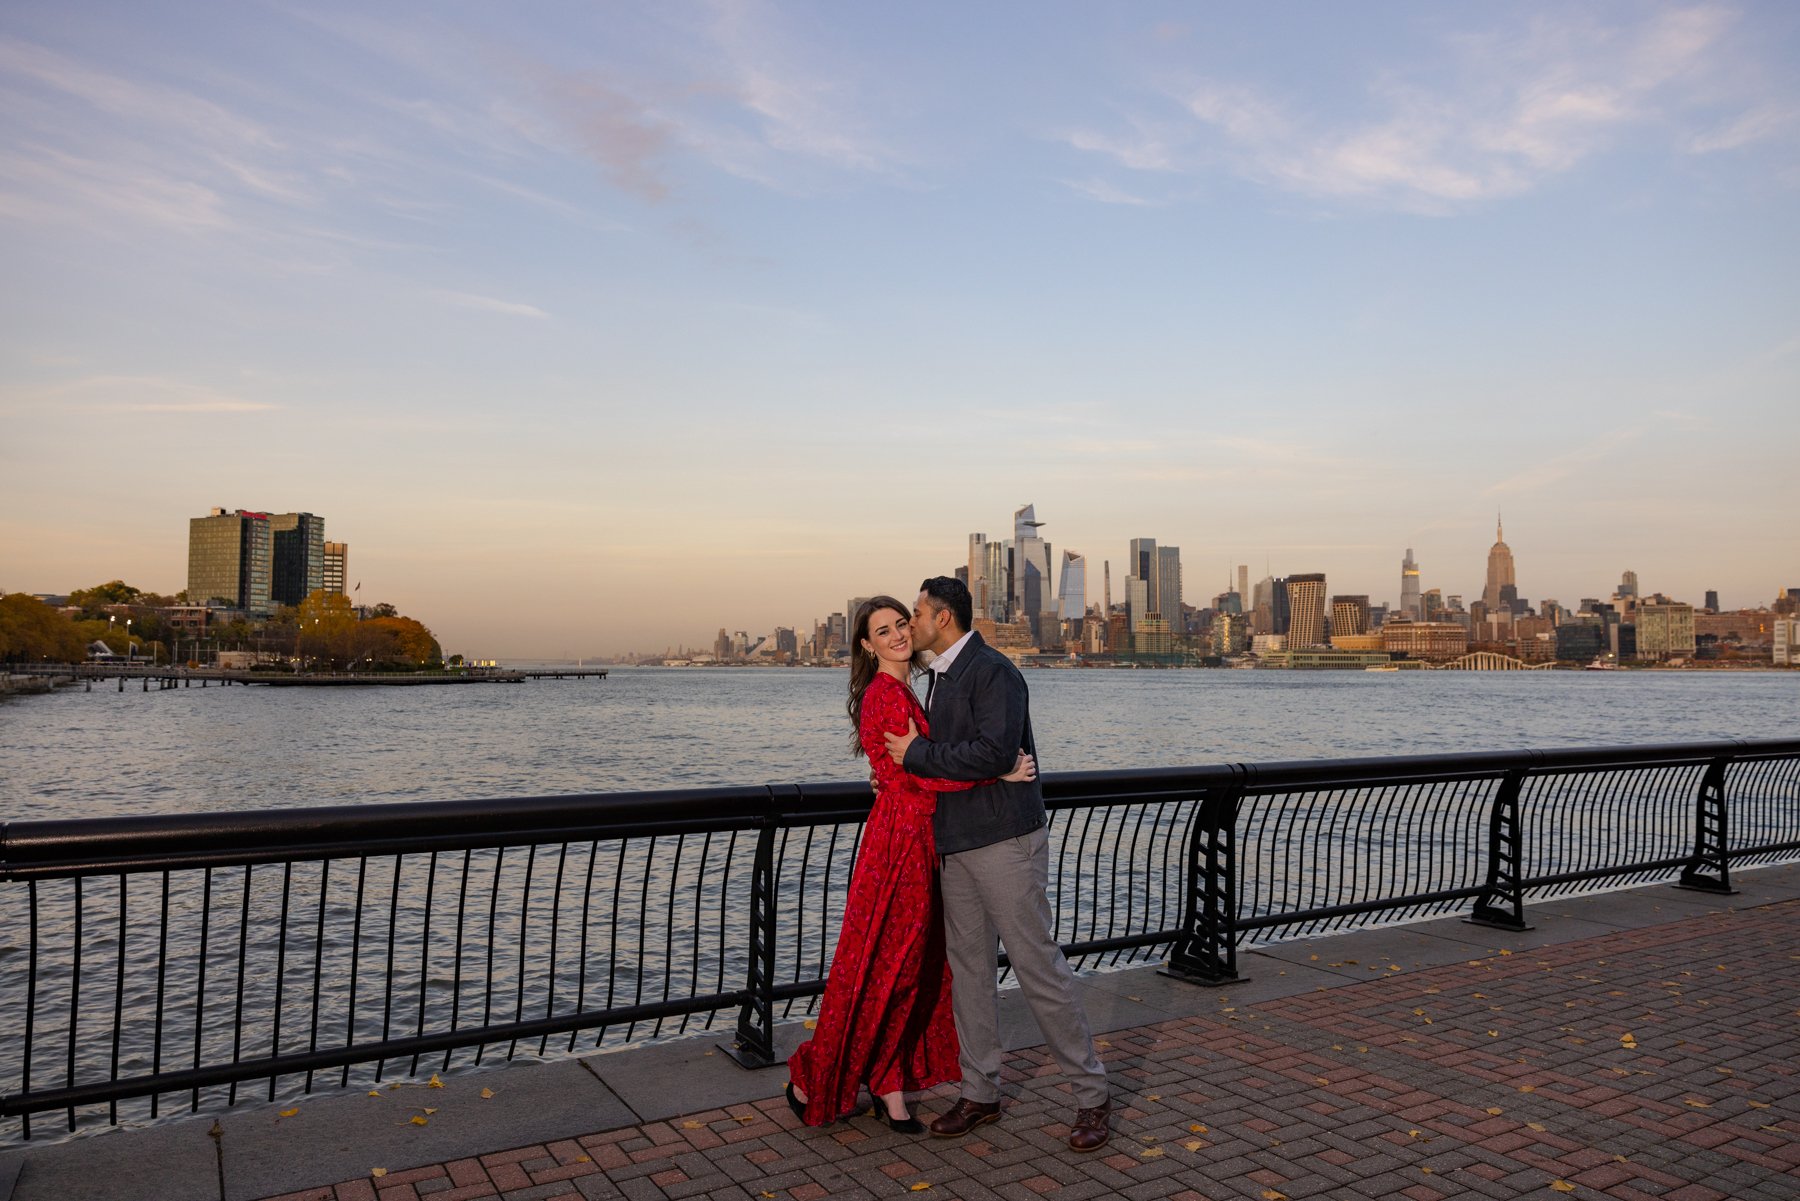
[0,0,1800,657]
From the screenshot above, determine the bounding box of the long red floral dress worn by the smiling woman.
[788,672,976,1125]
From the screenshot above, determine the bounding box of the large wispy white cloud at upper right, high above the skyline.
[1064,5,1764,212]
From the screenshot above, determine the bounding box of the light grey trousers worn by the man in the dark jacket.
[940,826,1109,1109]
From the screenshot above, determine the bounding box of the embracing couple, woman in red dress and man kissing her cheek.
[787,576,1112,1151]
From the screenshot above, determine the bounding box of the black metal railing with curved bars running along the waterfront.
[0,740,1800,1138]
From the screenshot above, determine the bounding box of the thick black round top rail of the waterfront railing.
[0,738,1800,879]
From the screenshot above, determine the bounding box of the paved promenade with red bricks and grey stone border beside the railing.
[0,866,1800,1201]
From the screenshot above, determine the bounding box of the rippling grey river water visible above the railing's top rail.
[0,668,1800,821]
